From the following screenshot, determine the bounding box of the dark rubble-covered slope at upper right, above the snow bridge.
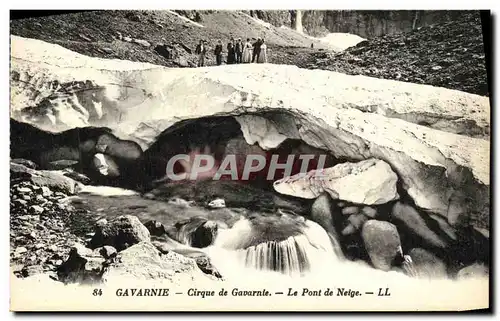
[296,12,489,96]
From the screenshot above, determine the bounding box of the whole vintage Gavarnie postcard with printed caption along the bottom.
[10,10,491,312]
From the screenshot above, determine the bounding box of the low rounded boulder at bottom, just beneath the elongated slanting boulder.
[408,248,448,279]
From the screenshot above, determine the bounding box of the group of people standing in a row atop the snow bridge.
[195,38,267,67]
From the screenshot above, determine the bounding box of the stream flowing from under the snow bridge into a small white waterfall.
[73,187,484,287]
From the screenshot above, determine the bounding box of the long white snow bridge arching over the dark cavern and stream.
[11,36,490,229]
